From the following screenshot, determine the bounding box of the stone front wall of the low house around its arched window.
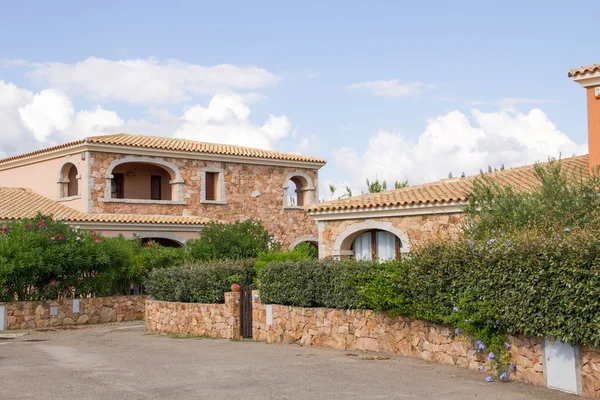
[319,213,462,258]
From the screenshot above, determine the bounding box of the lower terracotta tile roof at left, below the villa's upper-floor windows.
[0,187,208,225]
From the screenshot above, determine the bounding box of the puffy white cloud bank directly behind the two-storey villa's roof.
[0,80,291,158]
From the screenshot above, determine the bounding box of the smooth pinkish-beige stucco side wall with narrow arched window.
[0,153,88,211]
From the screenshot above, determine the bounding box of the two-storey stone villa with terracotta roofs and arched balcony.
[0,134,325,246]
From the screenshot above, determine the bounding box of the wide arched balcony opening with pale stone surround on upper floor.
[104,156,184,204]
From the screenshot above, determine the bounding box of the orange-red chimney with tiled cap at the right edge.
[569,64,600,169]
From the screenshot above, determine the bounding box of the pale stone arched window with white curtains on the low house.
[333,220,410,260]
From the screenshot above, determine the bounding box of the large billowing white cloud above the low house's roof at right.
[333,109,587,193]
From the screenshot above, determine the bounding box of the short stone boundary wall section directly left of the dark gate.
[146,292,240,339]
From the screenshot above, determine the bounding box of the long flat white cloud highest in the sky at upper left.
[18,57,280,104]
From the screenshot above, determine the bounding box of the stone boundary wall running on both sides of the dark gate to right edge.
[146,291,600,398]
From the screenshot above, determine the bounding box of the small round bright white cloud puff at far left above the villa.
[19,89,75,142]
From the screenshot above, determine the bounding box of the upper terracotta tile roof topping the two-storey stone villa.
[0,133,326,164]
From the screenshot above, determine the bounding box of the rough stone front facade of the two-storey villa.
[90,152,317,246]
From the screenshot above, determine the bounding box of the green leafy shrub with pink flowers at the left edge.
[0,215,185,301]
